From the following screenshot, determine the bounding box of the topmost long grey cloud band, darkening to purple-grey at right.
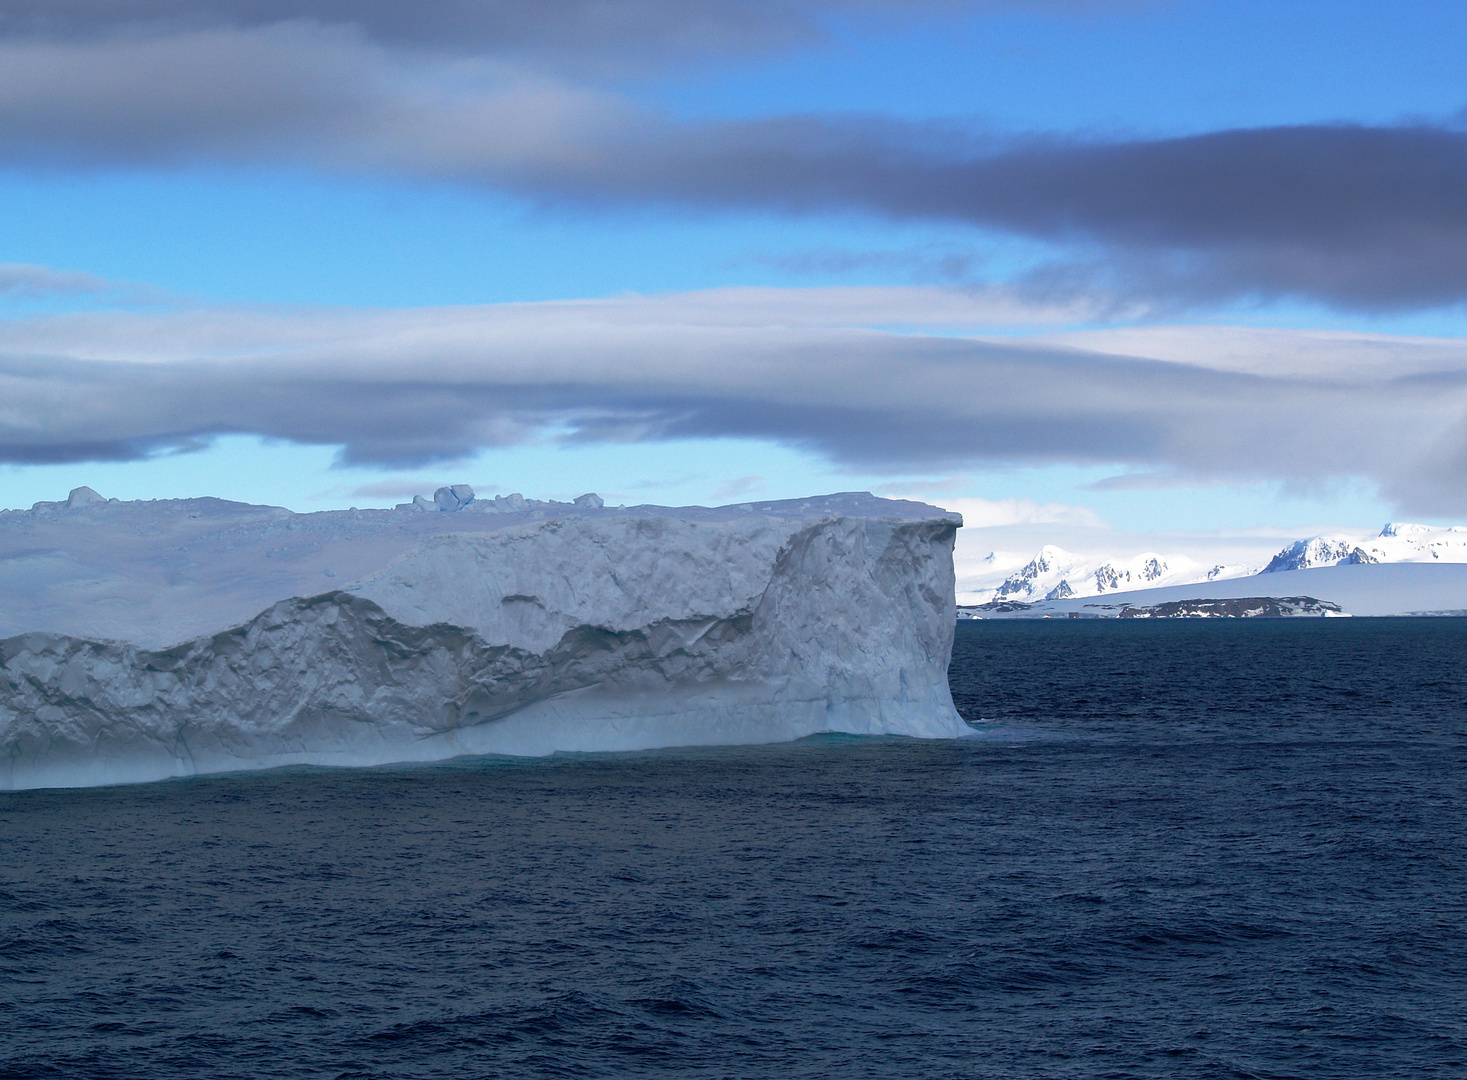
[0,9,1467,310]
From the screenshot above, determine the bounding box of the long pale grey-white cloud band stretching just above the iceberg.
[0,288,1467,515]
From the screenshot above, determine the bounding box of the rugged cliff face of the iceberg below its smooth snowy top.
[0,496,970,788]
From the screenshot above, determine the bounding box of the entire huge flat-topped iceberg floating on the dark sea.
[0,487,968,787]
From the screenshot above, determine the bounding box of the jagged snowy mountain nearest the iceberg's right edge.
[962,544,1257,603]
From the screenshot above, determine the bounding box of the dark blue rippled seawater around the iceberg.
[0,619,1467,1080]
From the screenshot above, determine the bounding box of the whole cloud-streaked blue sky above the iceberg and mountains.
[0,0,1467,578]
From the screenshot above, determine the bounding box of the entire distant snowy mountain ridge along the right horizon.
[959,522,1467,603]
